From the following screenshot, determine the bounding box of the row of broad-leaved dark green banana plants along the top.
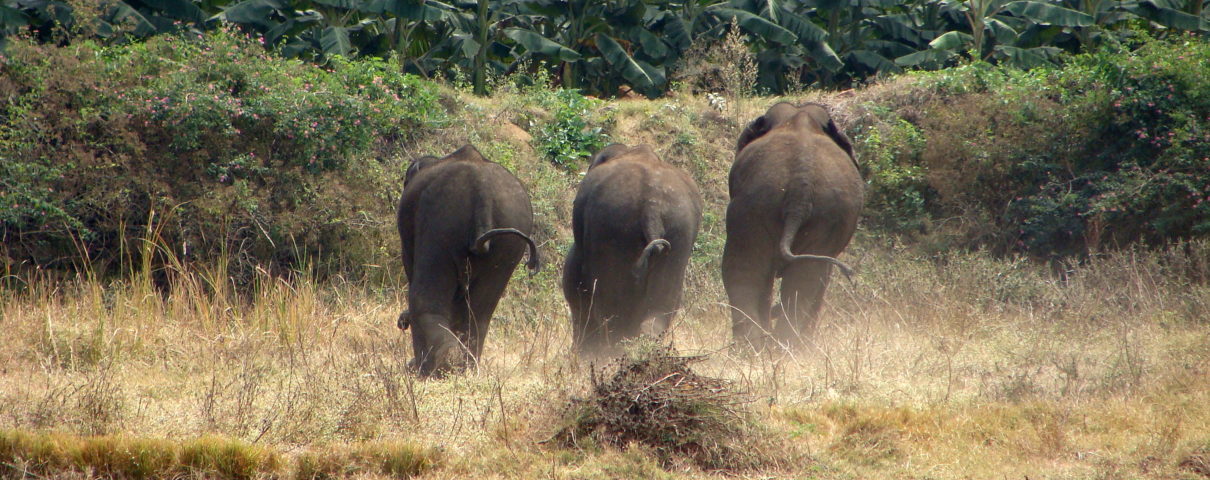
[0,0,1210,97]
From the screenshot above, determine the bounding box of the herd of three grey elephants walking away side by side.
[397,102,864,376]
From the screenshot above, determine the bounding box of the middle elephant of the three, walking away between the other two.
[563,144,702,355]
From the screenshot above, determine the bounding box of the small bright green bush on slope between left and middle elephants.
[534,88,611,169]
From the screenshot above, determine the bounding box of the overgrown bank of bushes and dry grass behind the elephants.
[0,31,1210,276]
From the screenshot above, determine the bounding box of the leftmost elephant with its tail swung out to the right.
[397,145,541,376]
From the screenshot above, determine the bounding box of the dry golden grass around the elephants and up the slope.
[7,86,1210,479]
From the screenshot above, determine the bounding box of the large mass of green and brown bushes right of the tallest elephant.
[854,36,1210,256]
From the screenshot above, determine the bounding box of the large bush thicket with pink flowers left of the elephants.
[0,31,445,276]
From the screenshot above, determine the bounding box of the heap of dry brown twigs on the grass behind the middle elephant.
[554,341,777,470]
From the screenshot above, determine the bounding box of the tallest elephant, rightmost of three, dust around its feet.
[722,102,864,347]
